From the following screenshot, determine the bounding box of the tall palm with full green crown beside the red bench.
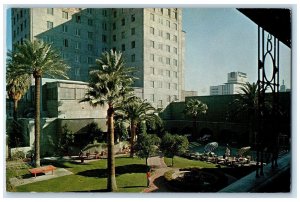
[8,40,69,167]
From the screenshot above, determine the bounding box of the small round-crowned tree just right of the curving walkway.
[160,133,189,166]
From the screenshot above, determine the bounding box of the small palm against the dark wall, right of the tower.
[184,99,208,138]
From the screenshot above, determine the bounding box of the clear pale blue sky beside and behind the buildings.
[6,8,291,95]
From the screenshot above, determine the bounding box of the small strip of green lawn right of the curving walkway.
[164,156,220,168]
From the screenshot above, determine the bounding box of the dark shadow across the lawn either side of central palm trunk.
[77,164,147,178]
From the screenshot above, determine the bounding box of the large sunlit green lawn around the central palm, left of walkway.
[7,157,146,192]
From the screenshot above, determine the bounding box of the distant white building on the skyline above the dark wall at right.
[210,72,248,95]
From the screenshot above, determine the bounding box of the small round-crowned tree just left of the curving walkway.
[135,134,160,166]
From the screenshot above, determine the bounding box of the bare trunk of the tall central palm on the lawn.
[107,104,117,192]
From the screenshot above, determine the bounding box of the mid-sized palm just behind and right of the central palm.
[116,96,162,157]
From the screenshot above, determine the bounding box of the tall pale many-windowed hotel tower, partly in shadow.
[11,8,185,107]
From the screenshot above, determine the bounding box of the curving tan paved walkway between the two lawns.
[143,156,177,193]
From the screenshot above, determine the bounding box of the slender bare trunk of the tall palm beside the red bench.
[34,76,41,167]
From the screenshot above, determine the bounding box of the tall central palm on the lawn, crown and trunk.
[81,50,133,191]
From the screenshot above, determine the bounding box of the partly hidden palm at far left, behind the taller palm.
[6,64,31,121]
